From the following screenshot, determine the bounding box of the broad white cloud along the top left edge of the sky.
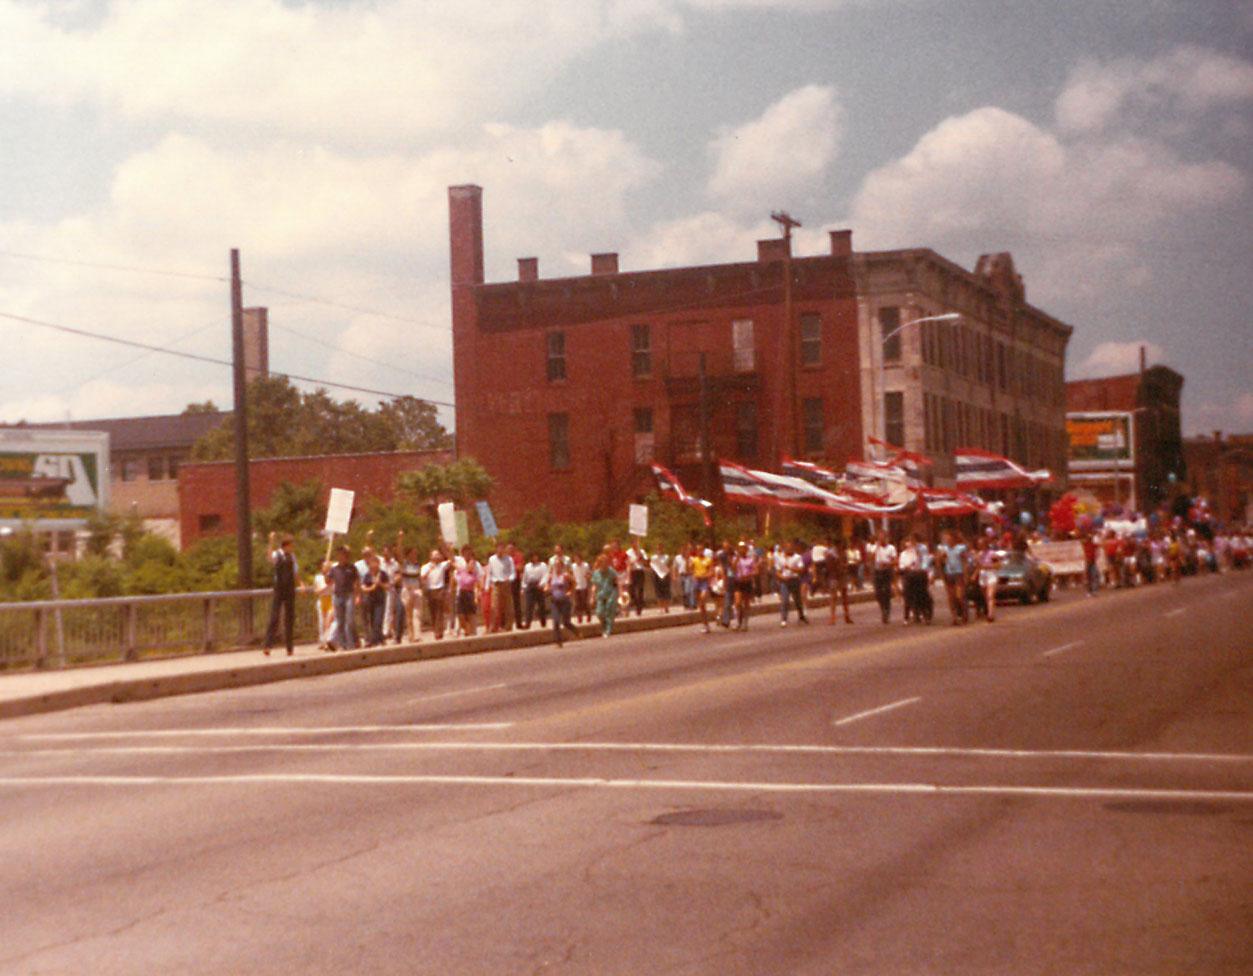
[0,0,680,144]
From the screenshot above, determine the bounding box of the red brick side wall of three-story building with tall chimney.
[449,185,863,522]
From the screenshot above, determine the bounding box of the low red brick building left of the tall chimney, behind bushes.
[178,451,451,549]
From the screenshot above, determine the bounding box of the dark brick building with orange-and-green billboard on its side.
[1066,366,1185,511]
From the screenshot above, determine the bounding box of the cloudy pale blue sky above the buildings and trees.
[0,0,1253,432]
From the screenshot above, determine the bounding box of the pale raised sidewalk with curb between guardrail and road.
[0,590,873,719]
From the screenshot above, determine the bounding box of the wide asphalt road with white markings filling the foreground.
[0,574,1253,976]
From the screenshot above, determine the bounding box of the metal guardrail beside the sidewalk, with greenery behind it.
[0,589,317,670]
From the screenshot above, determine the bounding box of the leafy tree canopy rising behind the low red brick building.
[188,376,452,461]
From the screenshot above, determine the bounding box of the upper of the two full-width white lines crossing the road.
[0,742,1253,763]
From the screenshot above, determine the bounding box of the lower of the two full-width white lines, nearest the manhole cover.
[0,773,1253,803]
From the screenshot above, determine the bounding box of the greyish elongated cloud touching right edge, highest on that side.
[1055,45,1253,132]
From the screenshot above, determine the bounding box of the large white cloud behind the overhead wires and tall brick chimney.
[0,122,659,420]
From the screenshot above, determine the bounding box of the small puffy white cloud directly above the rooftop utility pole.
[709,85,843,212]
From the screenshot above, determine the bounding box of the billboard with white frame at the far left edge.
[0,427,109,531]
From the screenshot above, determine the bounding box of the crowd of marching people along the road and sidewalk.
[266,526,1253,654]
